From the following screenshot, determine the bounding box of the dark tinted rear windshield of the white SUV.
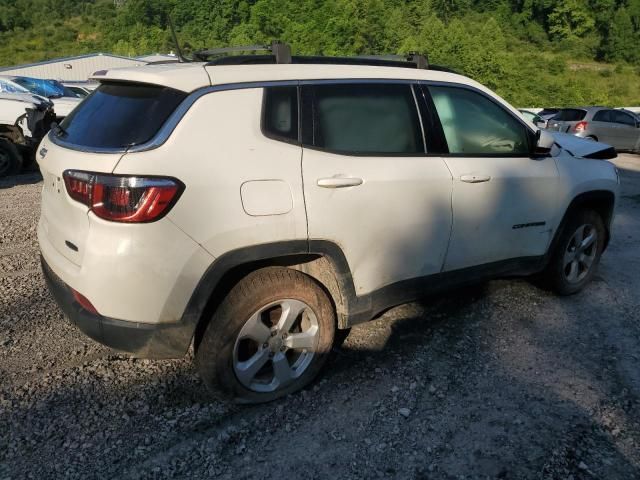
[62,83,187,148]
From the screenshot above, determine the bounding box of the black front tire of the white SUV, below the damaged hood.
[543,209,606,295]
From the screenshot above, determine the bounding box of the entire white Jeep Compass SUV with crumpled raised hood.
[38,44,619,403]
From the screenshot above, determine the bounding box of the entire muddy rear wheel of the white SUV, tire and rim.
[196,267,336,403]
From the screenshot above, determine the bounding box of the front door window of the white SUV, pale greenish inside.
[429,87,529,156]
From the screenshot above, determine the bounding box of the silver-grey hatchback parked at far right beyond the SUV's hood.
[547,107,640,152]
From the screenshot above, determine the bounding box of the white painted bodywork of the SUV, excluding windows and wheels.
[38,59,618,372]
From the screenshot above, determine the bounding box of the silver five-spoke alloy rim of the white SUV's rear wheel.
[233,299,320,393]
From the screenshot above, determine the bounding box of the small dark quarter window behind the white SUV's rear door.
[262,87,298,142]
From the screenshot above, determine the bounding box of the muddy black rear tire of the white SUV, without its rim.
[195,267,336,403]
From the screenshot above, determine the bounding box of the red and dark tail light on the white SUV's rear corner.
[63,170,184,223]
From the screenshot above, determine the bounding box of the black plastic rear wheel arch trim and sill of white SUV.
[181,239,545,350]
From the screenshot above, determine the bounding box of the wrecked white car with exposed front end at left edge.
[0,89,55,178]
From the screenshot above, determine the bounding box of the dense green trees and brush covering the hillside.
[0,0,640,105]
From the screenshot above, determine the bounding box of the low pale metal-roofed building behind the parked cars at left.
[0,53,149,82]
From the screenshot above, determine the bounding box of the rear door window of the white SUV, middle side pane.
[303,83,424,155]
